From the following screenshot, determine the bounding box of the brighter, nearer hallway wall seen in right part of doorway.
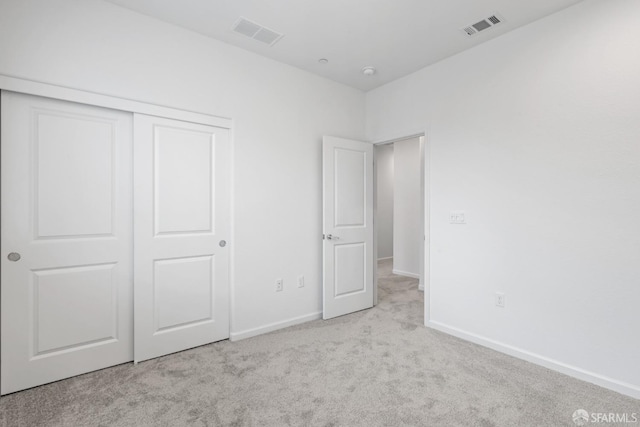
[393,137,423,277]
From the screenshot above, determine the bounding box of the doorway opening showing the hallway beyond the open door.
[374,134,427,322]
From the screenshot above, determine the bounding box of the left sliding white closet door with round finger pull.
[0,92,133,394]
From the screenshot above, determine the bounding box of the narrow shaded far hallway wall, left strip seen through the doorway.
[375,144,394,259]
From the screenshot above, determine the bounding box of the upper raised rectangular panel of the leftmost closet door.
[32,110,117,238]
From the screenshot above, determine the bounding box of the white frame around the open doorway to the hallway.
[373,128,431,326]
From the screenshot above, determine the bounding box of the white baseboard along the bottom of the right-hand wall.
[426,320,640,399]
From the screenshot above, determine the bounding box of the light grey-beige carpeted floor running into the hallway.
[0,261,640,427]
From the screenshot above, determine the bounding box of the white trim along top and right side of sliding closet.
[0,74,235,378]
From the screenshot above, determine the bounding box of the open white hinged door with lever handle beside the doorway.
[322,136,375,319]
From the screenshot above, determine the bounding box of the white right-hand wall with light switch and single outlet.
[367,0,640,397]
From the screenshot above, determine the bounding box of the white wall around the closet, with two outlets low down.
[0,0,364,334]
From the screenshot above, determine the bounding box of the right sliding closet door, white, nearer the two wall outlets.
[134,114,230,362]
